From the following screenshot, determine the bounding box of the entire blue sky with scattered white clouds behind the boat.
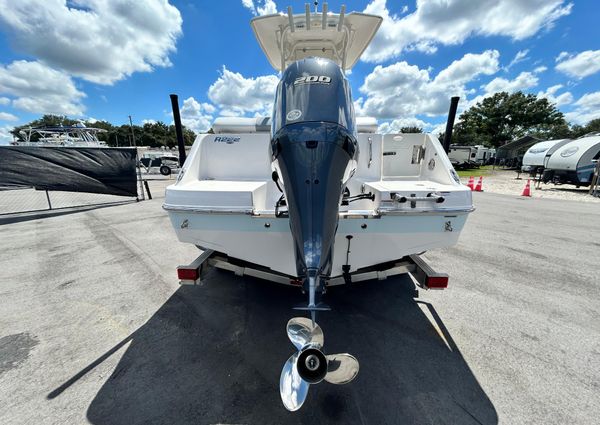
[0,0,600,143]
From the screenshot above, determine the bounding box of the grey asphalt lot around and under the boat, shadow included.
[0,181,600,425]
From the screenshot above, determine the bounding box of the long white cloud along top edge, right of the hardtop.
[363,0,573,62]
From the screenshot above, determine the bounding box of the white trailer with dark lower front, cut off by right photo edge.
[543,133,600,186]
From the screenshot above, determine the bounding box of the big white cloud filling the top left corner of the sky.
[0,0,182,84]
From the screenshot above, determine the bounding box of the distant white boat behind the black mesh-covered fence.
[12,124,108,148]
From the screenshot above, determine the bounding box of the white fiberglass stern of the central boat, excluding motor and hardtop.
[164,127,472,276]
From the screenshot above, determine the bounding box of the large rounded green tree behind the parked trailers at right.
[452,92,570,147]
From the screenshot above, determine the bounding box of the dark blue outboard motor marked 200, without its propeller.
[271,57,358,321]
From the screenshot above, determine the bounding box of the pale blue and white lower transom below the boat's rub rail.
[167,207,469,277]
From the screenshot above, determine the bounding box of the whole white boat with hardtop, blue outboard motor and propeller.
[164,4,473,410]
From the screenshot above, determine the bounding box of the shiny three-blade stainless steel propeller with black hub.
[279,317,358,412]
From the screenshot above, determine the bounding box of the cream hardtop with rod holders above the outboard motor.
[250,3,382,71]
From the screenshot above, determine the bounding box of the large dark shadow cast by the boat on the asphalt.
[48,271,498,425]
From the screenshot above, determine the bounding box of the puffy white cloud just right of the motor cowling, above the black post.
[355,50,500,119]
